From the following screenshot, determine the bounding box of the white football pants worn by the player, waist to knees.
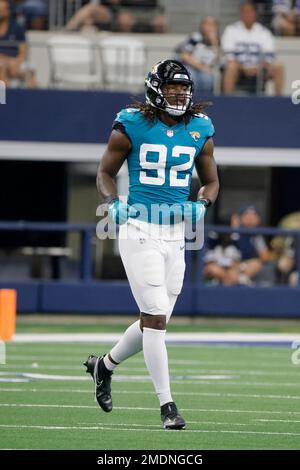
[119,219,185,321]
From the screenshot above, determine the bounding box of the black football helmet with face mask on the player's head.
[145,59,194,116]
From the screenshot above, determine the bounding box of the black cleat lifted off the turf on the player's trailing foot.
[83,356,113,413]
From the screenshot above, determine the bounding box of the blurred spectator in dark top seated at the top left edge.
[0,0,36,87]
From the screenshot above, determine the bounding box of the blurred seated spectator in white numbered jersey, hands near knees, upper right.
[221,2,284,95]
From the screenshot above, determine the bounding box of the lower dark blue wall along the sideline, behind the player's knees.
[0,281,300,318]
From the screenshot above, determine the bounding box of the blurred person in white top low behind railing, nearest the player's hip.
[204,232,241,286]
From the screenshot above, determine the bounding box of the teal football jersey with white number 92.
[116,108,215,222]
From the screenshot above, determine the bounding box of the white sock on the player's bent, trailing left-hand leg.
[104,320,143,370]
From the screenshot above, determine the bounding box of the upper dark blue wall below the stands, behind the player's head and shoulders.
[0,90,300,148]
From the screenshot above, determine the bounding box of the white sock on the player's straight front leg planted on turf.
[143,328,173,406]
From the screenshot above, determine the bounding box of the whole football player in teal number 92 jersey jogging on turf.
[85,60,219,429]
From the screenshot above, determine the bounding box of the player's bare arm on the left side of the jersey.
[97,130,131,200]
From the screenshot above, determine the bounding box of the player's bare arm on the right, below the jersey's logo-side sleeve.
[195,138,219,204]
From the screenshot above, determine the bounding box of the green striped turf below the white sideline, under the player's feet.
[0,336,300,450]
